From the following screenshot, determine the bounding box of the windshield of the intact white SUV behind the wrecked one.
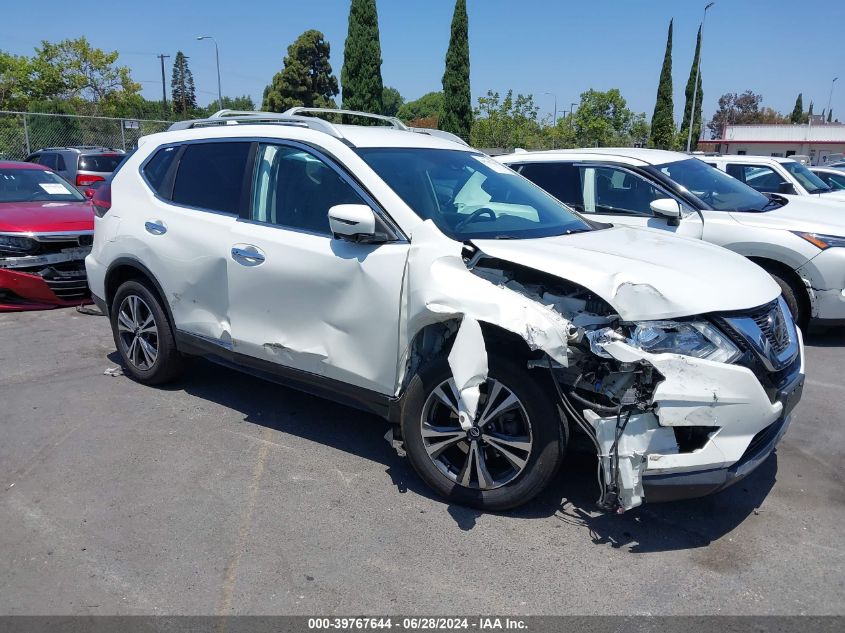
[653,158,771,211]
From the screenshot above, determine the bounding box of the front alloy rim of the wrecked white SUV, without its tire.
[420,378,532,490]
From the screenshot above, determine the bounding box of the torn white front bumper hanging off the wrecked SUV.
[584,330,804,510]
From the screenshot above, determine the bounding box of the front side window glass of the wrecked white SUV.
[250,145,366,235]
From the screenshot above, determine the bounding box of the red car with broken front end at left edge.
[0,161,94,312]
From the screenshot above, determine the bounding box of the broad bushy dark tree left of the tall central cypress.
[261,29,338,112]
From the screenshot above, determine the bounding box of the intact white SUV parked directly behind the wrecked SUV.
[499,148,845,324]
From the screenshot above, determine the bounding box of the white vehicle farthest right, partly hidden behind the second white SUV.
[701,154,845,201]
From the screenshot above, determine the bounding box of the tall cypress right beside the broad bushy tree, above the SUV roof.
[340,0,384,113]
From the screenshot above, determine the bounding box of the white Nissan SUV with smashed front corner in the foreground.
[86,109,804,511]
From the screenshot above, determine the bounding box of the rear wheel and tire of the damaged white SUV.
[110,280,184,385]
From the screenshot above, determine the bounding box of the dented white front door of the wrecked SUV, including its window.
[228,144,408,394]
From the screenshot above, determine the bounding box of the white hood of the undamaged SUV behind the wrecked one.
[731,195,845,235]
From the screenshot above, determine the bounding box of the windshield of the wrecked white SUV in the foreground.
[357,148,591,241]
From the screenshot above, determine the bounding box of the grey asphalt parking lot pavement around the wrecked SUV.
[0,309,845,615]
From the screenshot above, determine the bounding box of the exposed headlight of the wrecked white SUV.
[626,321,741,363]
